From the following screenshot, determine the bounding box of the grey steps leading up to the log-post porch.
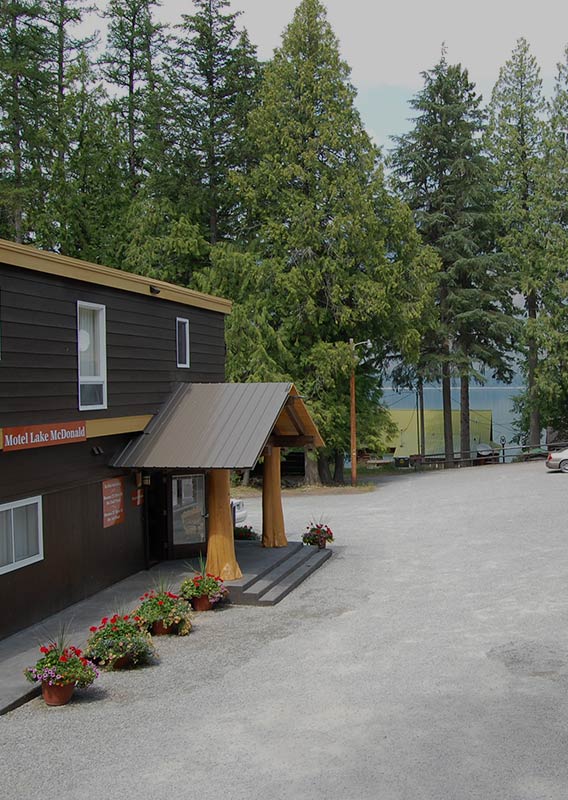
[231,545,332,606]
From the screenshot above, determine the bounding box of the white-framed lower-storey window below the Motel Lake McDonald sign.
[0,497,43,575]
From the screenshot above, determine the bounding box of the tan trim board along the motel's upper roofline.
[0,239,232,314]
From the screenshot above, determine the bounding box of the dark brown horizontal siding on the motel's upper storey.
[0,264,225,427]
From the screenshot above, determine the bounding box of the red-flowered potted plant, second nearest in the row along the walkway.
[85,614,155,669]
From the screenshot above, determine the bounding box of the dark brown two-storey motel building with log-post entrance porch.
[0,239,323,638]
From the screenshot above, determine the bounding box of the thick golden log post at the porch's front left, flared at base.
[205,469,243,581]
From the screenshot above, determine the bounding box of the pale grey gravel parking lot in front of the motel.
[0,462,568,800]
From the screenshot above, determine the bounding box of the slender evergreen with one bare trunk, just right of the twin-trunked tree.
[488,38,547,446]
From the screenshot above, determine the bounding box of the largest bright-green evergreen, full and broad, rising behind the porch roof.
[203,0,429,478]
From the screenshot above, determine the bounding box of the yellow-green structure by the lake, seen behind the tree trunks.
[387,408,492,458]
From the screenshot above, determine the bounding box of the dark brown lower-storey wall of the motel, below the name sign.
[0,436,144,638]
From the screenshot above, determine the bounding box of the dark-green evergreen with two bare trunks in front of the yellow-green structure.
[392,54,512,461]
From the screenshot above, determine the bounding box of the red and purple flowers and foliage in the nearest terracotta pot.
[24,639,99,689]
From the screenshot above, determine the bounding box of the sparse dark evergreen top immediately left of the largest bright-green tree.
[172,0,260,244]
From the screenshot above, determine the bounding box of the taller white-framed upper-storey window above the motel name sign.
[77,300,107,411]
